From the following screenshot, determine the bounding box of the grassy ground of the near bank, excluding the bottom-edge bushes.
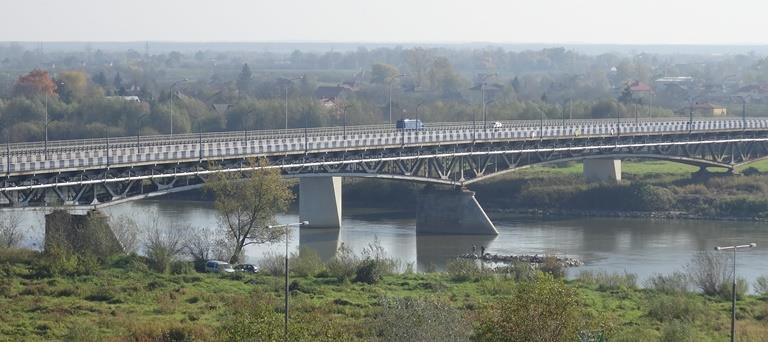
[0,250,768,341]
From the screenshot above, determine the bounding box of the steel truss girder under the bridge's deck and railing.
[0,132,768,207]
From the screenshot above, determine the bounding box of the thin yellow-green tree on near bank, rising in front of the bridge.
[206,159,293,263]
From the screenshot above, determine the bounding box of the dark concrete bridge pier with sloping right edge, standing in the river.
[416,187,499,235]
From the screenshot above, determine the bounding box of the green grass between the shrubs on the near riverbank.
[0,252,768,340]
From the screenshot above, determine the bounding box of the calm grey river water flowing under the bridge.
[10,200,768,284]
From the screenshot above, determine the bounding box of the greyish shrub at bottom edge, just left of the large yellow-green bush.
[374,298,472,341]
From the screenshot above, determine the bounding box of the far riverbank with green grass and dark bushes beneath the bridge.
[345,162,768,219]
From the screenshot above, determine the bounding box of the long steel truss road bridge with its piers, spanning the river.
[0,118,768,233]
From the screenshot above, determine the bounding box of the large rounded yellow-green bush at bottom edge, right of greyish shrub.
[476,273,582,341]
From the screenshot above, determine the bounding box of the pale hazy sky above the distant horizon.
[6,0,768,44]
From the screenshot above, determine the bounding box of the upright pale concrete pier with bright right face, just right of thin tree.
[299,177,341,228]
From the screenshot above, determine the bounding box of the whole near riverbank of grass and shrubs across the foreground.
[0,243,768,341]
